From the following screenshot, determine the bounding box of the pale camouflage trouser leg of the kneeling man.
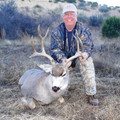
[80,57,96,95]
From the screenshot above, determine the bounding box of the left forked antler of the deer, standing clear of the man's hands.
[29,25,55,65]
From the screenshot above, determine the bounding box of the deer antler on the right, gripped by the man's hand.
[65,30,85,65]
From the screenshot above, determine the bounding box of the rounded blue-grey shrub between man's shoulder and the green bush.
[89,15,103,26]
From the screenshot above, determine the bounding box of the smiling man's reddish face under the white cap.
[63,11,77,26]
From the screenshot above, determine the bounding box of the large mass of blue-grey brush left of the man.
[0,1,60,40]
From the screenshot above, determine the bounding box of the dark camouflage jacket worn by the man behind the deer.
[50,22,94,66]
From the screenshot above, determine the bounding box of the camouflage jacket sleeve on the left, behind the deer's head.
[50,23,66,63]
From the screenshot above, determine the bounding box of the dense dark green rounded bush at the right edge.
[102,16,120,38]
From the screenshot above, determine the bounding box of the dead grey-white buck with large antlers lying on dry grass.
[19,26,83,109]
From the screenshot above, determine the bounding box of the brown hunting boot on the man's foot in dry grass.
[87,95,99,106]
